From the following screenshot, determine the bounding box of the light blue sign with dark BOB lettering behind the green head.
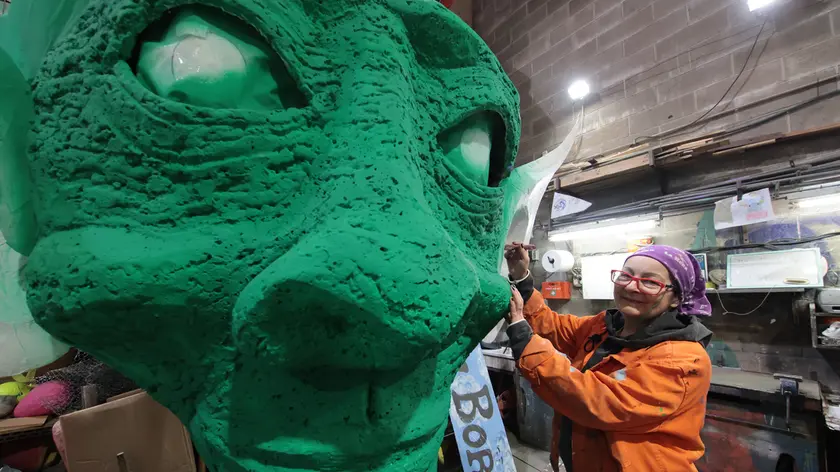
[449,346,516,472]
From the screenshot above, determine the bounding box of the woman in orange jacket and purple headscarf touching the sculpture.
[505,244,712,472]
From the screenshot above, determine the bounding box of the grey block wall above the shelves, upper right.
[473,0,840,164]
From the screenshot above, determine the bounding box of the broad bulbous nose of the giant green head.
[233,210,481,371]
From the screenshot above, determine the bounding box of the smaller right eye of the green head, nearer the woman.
[438,113,505,187]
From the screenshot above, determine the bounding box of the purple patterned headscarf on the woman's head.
[627,245,712,316]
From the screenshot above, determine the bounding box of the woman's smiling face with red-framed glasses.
[613,256,679,320]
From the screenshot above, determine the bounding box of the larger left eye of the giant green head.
[132,5,306,110]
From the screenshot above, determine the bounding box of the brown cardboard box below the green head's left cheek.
[61,392,196,472]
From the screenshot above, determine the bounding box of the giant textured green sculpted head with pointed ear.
[0,0,568,471]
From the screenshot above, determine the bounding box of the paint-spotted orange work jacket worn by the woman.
[509,291,712,472]
